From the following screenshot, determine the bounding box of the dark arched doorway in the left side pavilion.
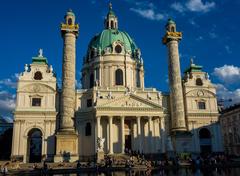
[28,128,42,163]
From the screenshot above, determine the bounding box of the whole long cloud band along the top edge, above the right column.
[171,0,216,13]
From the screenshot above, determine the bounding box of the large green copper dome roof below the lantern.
[88,29,138,54]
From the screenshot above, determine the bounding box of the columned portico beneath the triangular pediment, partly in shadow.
[95,115,164,154]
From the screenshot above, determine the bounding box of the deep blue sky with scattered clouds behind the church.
[0,0,240,117]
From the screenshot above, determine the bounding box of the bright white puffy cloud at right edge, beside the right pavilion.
[213,65,240,84]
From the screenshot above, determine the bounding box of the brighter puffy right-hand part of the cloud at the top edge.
[186,0,216,12]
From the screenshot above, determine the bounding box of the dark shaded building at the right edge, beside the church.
[219,104,240,156]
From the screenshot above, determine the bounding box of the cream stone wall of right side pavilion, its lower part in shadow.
[183,68,223,153]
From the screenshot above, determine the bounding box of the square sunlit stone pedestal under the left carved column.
[54,131,79,162]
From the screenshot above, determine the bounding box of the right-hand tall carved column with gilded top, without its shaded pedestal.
[163,19,186,132]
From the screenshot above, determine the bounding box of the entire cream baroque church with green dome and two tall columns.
[12,5,223,162]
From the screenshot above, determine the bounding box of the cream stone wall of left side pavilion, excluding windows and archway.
[12,64,58,162]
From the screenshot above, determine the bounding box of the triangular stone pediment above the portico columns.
[97,94,163,110]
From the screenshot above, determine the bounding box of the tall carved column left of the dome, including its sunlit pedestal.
[54,10,79,161]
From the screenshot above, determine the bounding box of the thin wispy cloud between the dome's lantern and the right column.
[130,8,165,21]
